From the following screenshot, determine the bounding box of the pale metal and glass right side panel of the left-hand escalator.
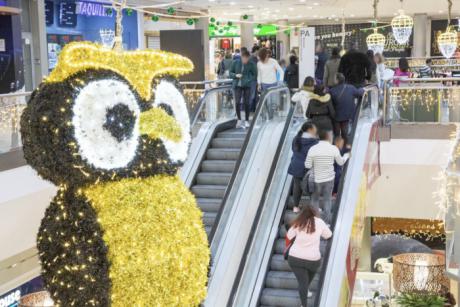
[204,86,294,306]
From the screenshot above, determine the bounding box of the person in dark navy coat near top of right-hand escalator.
[329,73,364,144]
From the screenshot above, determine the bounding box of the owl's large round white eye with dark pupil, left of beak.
[72,80,141,170]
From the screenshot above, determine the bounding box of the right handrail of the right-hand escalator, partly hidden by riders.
[314,85,377,306]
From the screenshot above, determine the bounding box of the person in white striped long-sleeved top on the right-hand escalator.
[305,130,347,224]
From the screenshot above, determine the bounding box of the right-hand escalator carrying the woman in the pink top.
[230,87,379,307]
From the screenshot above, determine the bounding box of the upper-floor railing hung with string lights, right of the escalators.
[383,78,460,123]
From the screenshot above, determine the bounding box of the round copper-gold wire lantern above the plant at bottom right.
[393,253,449,294]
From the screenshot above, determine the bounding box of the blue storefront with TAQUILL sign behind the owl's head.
[45,0,138,70]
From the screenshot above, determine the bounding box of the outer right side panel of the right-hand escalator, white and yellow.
[314,87,381,306]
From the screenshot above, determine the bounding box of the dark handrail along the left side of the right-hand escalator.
[227,101,296,307]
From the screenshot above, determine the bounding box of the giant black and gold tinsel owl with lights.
[21,43,209,307]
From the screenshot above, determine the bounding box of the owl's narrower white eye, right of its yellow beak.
[153,79,191,162]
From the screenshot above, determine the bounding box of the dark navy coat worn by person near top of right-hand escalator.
[329,83,364,122]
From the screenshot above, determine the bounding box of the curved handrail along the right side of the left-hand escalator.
[209,85,291,244]
